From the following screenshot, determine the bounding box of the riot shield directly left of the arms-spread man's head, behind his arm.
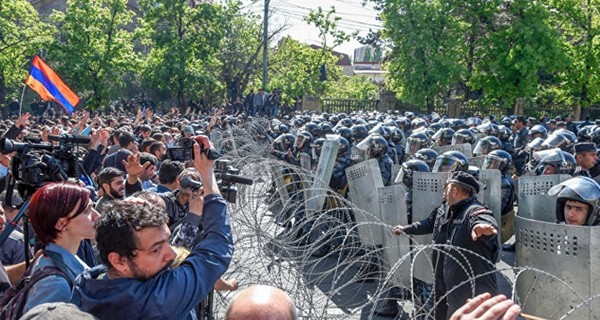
[411,172,448,283]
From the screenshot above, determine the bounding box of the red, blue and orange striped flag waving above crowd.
[25,55,79,114]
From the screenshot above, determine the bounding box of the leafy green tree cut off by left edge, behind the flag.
[0,0,52,106]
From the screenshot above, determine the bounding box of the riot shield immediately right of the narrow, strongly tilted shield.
[346,159,383,246]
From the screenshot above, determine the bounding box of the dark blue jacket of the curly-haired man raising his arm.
[72,195,233,319]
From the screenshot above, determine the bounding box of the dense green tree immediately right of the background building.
[378,0,465,112]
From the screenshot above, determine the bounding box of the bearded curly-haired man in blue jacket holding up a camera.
[73,137,233,319]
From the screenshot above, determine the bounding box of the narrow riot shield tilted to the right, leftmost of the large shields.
[306,140,340,212]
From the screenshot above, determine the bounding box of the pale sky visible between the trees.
[242,0,382,58]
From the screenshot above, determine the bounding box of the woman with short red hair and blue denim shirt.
[23,182,100,313]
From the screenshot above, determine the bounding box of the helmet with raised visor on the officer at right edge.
[548,176,600,226]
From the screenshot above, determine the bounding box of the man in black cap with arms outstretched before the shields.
[393,171,499,319]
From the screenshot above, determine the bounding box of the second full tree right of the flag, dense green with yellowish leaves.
[139,0,227,107]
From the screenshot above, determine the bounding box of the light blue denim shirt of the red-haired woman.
[23,243,88,314]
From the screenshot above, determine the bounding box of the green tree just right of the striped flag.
[48,0,136,108]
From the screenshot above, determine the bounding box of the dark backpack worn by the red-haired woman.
[0,252,73,320]
